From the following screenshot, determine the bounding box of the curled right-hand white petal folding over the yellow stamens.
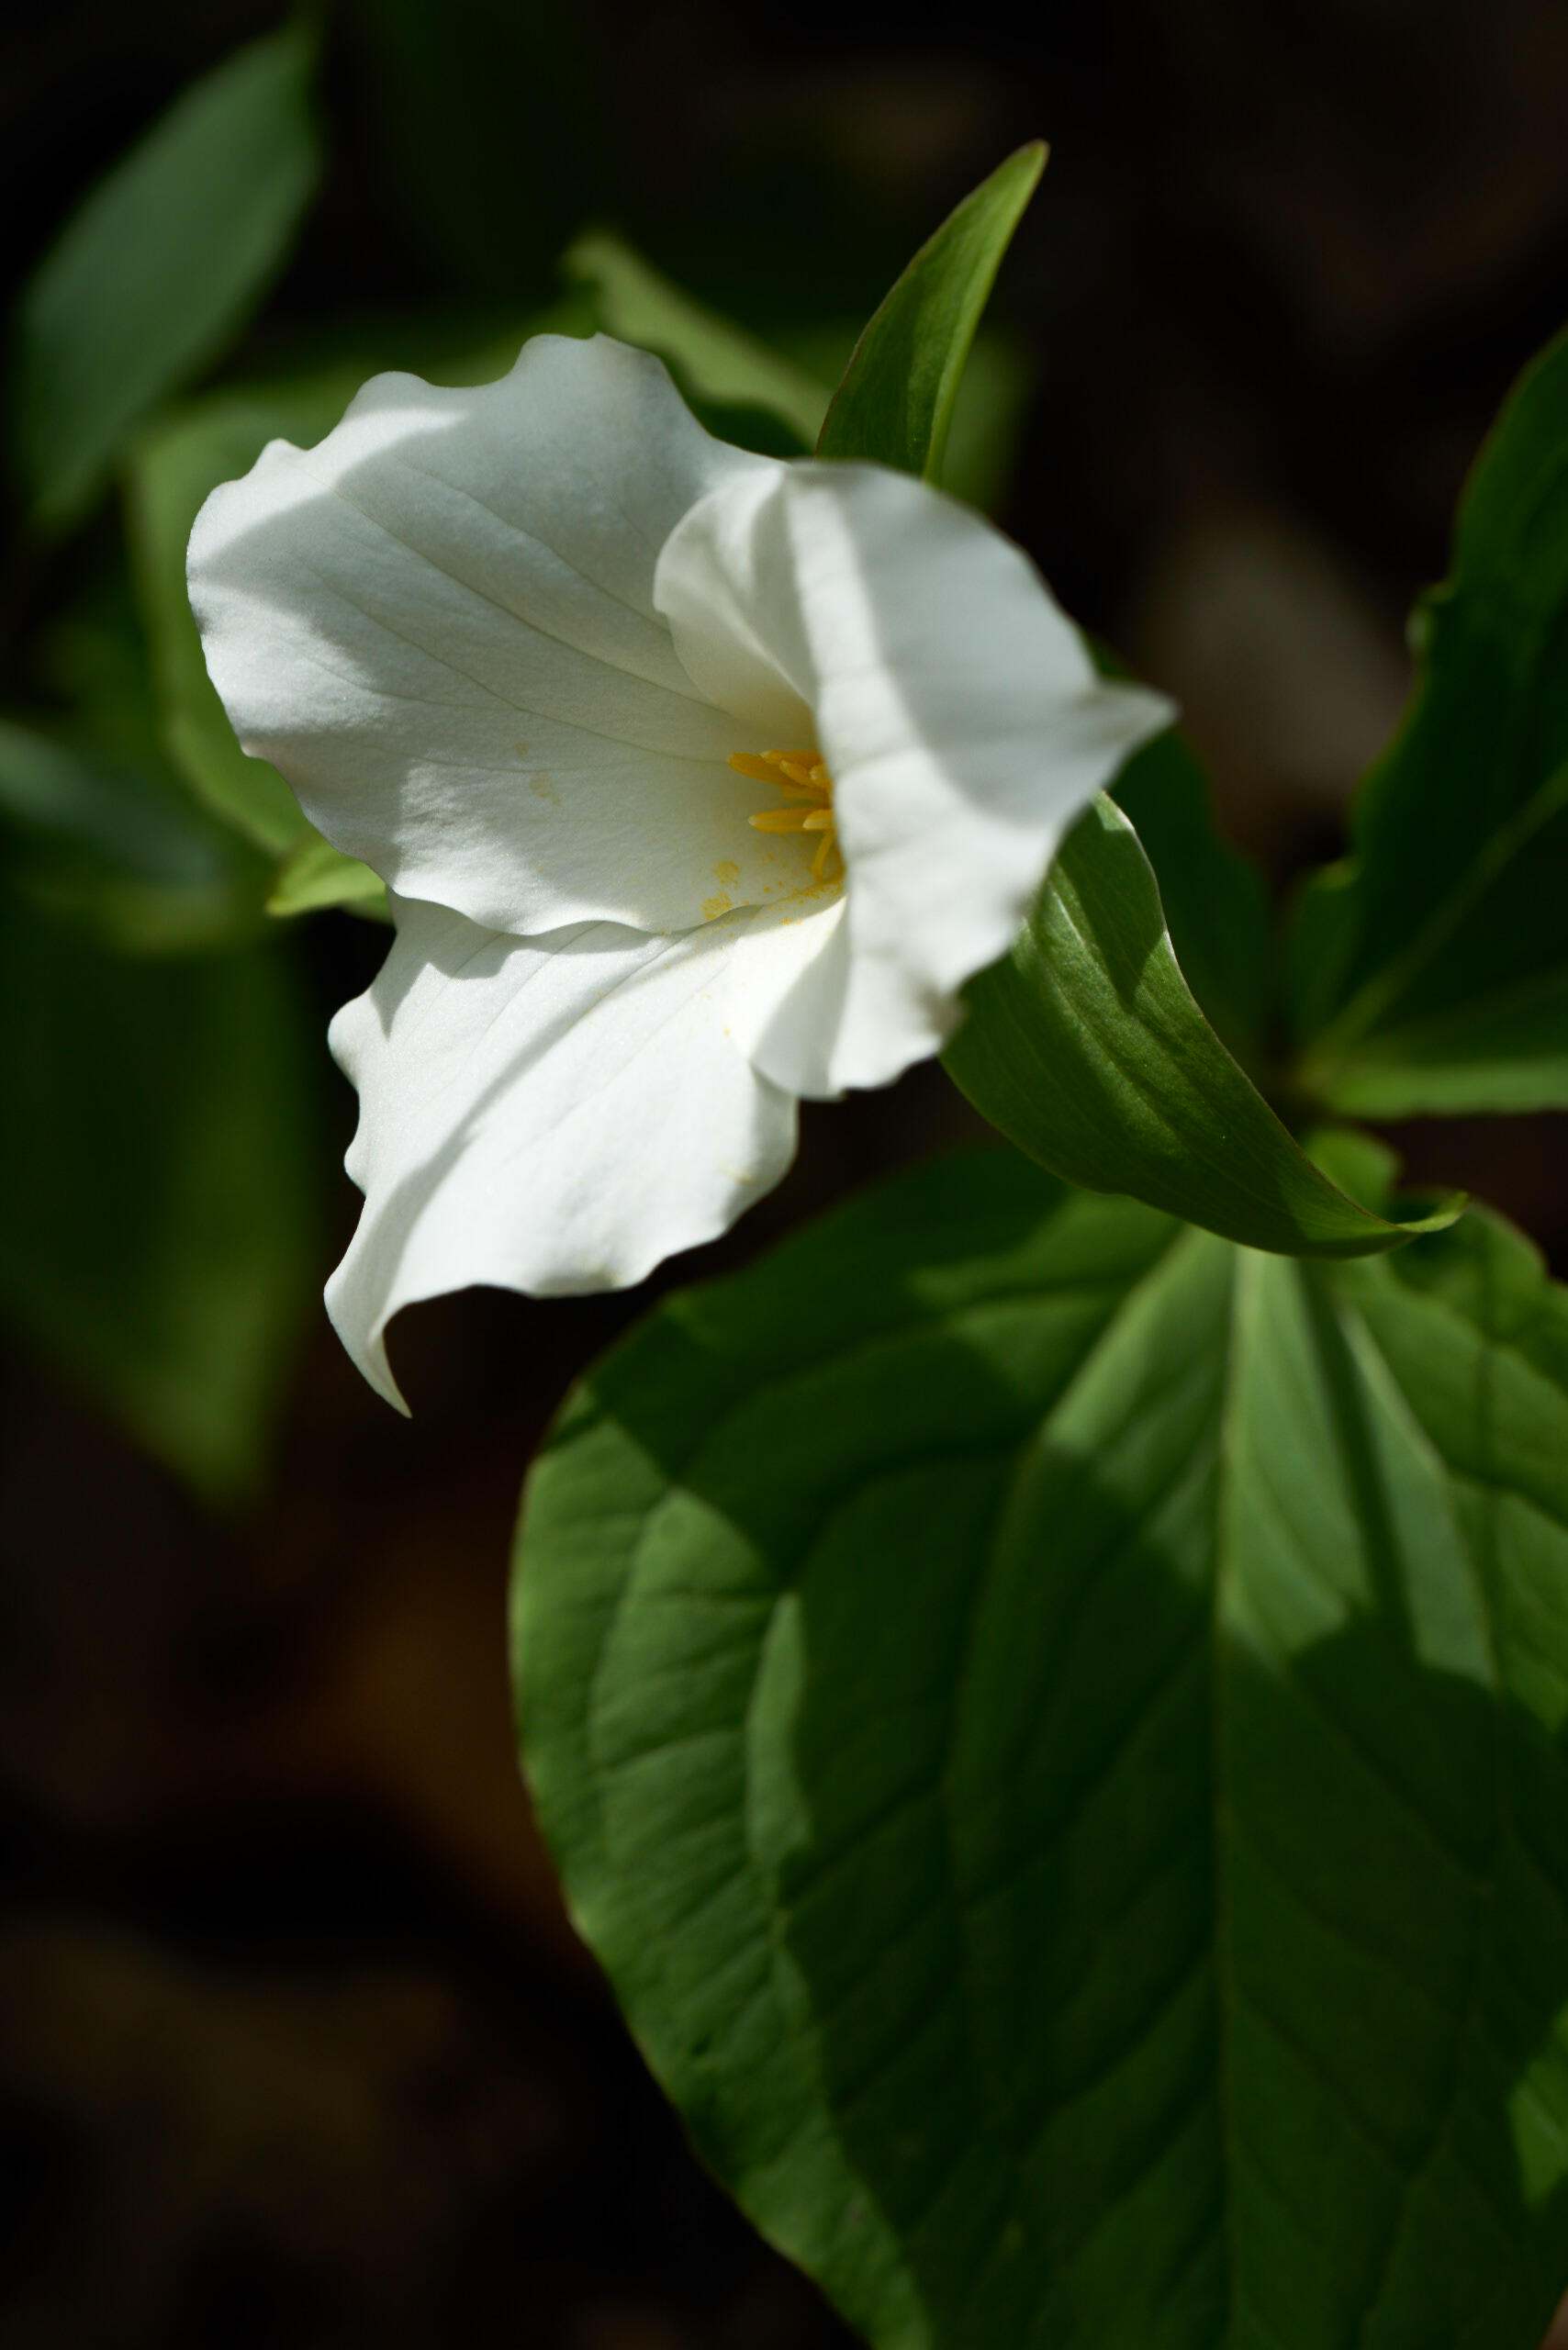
[654,463,1170,1095]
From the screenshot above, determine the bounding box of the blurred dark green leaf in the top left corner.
[14,28,319,529]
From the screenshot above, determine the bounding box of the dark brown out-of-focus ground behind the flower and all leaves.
[0,0,1568,2350]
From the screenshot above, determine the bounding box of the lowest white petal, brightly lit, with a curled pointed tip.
[327,900,801,1405]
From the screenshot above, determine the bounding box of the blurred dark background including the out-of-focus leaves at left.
[0,0,1568,2350]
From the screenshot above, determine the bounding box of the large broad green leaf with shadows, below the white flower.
[515,1158,1568,2350]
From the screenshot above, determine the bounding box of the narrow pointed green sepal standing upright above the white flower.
[816,139,1047,479]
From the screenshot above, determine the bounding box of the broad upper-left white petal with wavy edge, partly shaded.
[190,336,799,933]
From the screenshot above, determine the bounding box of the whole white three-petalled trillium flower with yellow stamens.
[190,336,1170,1403]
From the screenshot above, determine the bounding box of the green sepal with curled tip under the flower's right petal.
[943,799,1460,1258]
